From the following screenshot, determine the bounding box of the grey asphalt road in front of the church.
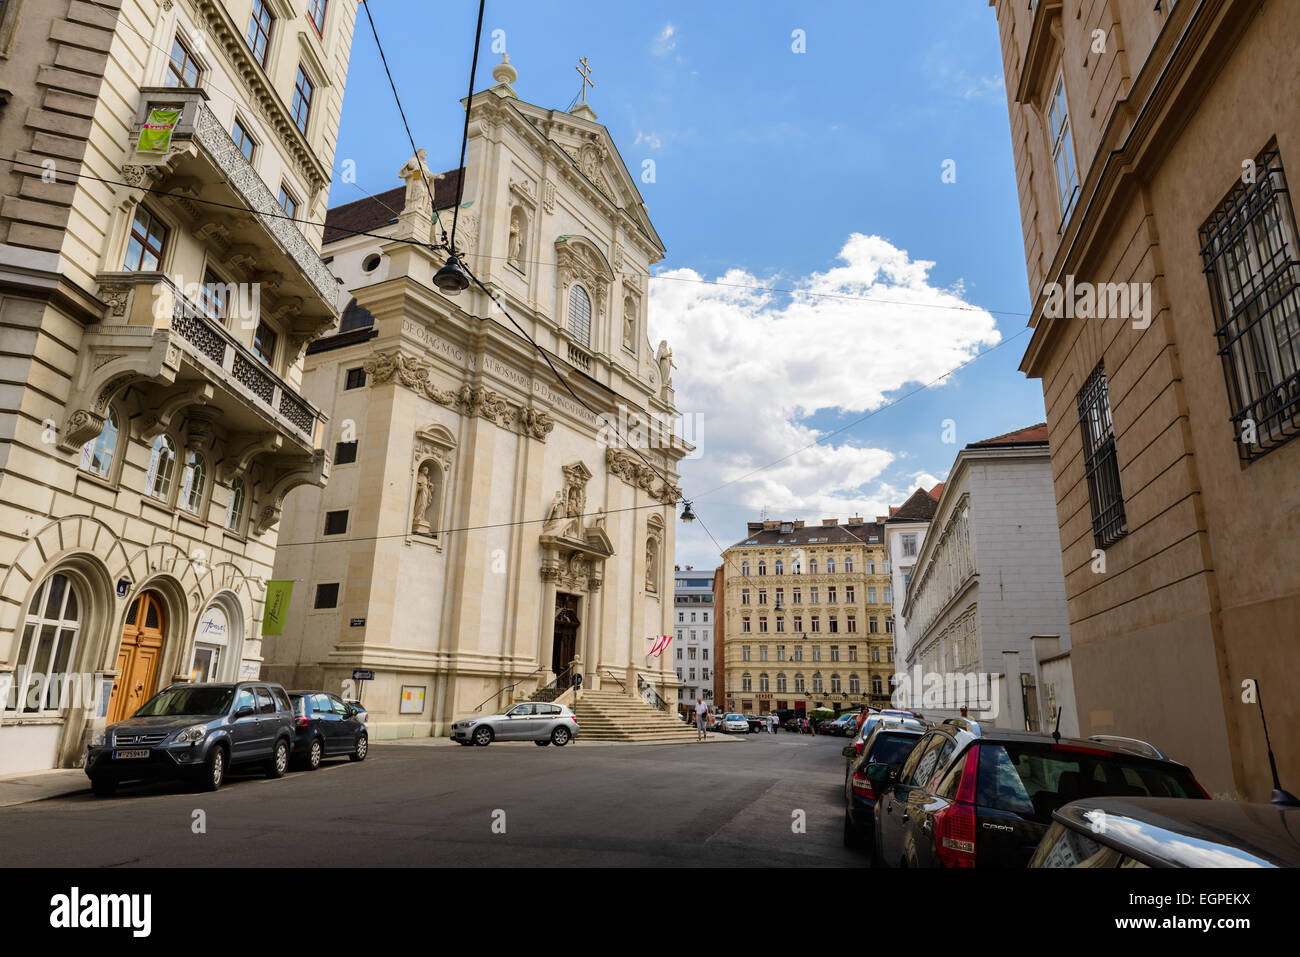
[0,733,867,867]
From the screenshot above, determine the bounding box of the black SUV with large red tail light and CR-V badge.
[867,718,1209,867]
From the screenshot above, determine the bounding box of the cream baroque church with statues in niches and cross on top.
[264,60,692,739]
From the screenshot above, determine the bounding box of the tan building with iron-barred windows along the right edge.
[991,0,1300,800]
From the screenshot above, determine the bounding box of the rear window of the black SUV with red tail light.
[976,741,1204,824]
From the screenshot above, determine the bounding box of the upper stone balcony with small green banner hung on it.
[122,87,338,338]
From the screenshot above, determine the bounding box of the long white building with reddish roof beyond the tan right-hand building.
[900,425,1074,733]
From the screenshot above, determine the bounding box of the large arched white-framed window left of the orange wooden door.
[8,573,82,713]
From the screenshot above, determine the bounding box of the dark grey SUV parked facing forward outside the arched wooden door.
[86,681,294,796]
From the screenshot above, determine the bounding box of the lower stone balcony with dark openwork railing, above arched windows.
[59,273,329,533]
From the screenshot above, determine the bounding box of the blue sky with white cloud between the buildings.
[332,0,1044,567]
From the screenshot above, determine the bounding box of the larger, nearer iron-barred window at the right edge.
[1200,148,1300,462]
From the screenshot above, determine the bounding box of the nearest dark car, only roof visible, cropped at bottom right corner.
[1030,797,1300,867]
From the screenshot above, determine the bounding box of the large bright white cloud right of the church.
[650,233,1001,560]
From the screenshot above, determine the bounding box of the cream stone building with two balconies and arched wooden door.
[0,0,356,771]
